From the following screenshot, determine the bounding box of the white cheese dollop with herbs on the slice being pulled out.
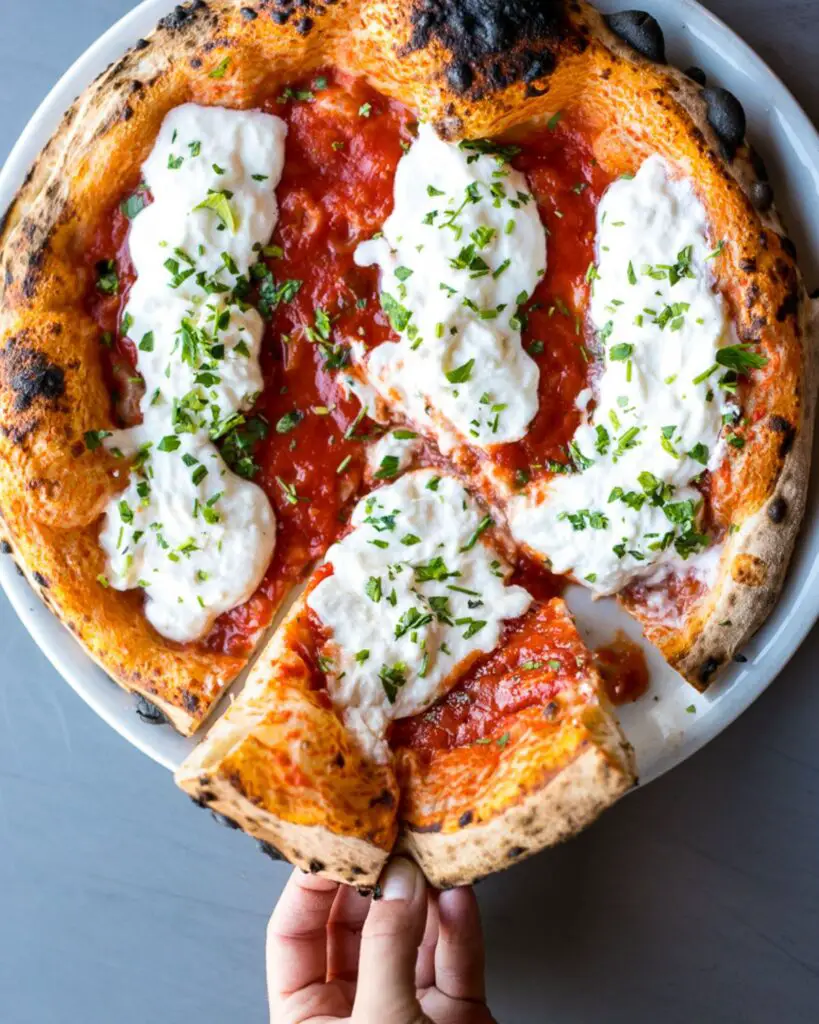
[308,470,531,759]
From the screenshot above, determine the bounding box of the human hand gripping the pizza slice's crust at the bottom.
[267,857,494,1024]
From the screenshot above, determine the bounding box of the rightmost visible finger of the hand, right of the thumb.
[435,888,485,999]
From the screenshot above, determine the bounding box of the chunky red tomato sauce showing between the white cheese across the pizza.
[78,71,647,679]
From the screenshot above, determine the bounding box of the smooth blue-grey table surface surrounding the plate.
[0,0,819,1024]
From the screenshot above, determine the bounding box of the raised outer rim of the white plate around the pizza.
[0,0,819,784]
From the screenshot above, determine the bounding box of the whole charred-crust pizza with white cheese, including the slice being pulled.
[0,0,814,887]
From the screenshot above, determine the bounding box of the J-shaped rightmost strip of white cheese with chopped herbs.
[510,157,731,593]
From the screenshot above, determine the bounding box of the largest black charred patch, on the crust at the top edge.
[405,0,579,93]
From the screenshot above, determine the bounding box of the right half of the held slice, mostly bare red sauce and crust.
[390,598,635,888]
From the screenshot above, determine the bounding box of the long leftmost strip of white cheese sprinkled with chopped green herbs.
[100,103,287,642]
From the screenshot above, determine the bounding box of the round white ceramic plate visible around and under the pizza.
[0,0,819,782]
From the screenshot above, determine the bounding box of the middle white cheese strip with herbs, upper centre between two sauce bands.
[355,125,546,450]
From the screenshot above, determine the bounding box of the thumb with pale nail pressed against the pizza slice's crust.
[353,857,428,1024]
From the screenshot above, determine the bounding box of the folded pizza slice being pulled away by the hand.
[177,469,634,886]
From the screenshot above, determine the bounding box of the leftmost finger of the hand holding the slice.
[267,869,339,1005]
